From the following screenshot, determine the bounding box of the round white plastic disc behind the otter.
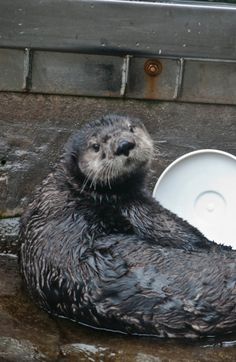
[153,149,236,249]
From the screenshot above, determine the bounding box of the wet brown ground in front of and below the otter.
[0,255,236,362]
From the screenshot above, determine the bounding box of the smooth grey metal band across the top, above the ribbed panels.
[0,0,236,59]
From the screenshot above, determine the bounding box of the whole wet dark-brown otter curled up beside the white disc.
[20,115,236,338]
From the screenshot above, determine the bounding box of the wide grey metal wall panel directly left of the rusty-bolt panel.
[32,51,123,97]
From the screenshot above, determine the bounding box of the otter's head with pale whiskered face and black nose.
[64,115,153,189]
